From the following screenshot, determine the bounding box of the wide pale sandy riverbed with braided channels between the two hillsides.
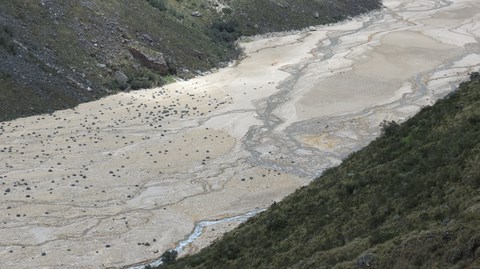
[0,0,480,268]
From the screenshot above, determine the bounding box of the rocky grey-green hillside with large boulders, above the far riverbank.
[0,0,380,121]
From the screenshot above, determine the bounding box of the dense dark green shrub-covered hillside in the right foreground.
[161,73,480,269]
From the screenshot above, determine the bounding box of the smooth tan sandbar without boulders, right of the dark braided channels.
[296,31,461,120]
